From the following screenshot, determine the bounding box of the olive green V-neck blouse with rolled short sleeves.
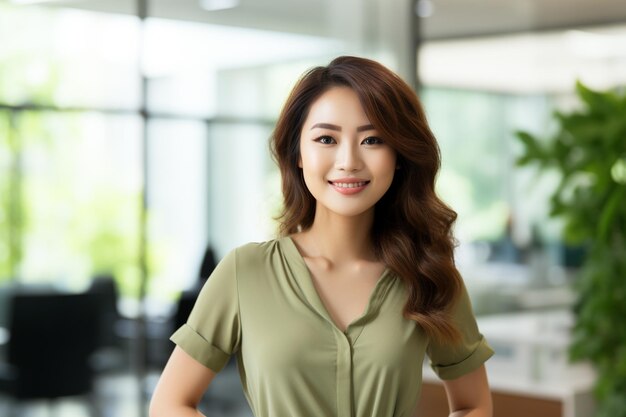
[172,237,493,417]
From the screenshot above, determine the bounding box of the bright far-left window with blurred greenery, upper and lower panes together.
[0,4,142,296]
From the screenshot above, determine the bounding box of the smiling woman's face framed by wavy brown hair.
[298,87,396,216]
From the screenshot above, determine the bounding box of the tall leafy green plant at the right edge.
[517,82,626,417]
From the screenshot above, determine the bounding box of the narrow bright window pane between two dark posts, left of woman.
[147,119,207,305]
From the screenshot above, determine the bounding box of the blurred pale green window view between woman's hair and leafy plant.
[421,87,560,262]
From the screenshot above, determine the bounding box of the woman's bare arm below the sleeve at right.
[443,365,493,417]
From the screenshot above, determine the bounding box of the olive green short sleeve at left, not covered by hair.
[171,250,241,372]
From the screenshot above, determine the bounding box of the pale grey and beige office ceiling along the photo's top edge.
[8,0,626,40]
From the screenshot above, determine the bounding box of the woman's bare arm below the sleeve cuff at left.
[150,346,215,417]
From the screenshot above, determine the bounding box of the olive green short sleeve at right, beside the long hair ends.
[427,285,493,379]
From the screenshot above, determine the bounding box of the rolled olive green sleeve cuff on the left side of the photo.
[170,324,230,372]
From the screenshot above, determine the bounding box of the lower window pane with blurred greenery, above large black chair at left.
[16,111,142,295]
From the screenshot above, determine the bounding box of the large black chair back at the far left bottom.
[0,293,99,414]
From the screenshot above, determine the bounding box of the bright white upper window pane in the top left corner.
[0,4,140,109]
